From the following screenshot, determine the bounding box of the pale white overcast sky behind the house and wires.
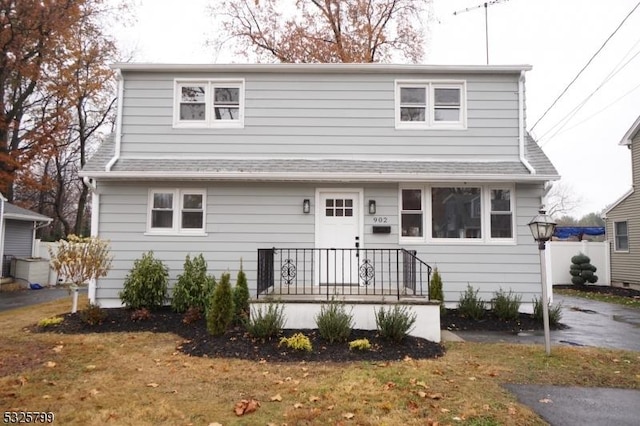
[117,0,640,217]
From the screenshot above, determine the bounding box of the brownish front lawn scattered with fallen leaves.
[0,299,640,425]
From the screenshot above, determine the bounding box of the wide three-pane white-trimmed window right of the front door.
[398,184,515,244]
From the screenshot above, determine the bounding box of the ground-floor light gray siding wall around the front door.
[97,182,541,305]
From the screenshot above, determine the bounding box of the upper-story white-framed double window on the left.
[174,80,244,128]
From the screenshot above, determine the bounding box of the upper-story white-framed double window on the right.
[396,81,466,129]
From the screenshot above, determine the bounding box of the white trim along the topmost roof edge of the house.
[111,63,532,74]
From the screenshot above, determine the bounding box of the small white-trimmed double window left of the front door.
[147,189,206,234]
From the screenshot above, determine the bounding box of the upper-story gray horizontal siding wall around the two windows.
[121,72,519,161]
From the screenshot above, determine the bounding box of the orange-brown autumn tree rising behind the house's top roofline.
[211,0,431,63]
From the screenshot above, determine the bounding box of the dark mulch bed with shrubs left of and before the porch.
[34,308,444,362]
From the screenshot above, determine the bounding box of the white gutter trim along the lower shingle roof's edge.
[81,171,560,182]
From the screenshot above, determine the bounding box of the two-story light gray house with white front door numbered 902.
[81,64,559,307]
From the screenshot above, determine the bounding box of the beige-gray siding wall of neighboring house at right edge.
[606,133,640,285]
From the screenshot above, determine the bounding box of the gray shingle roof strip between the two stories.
[82,135,558,180]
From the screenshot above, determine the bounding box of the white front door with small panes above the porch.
[316,191,361,285]
